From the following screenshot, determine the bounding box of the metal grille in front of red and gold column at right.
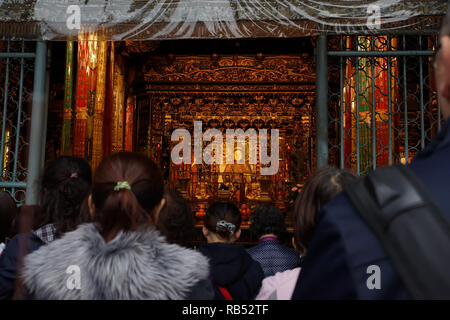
[328,34,443,174]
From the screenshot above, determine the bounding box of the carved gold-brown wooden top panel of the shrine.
[140,54,315,83]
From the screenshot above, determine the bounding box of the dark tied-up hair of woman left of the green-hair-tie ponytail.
[34,156,92,237]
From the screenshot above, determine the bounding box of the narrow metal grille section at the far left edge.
[0,41,35,203]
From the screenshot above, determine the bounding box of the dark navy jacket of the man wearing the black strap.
[293,120,450,299]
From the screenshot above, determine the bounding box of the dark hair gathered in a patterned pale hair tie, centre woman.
[204,202,242,240]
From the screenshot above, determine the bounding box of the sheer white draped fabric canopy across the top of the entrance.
[0,0,447,41]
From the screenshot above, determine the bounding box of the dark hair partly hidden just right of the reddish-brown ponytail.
[157,190,195,246]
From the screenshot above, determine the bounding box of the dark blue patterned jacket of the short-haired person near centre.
[248,240,300,277]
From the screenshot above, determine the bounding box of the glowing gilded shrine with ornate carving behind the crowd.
[135,53,315,216]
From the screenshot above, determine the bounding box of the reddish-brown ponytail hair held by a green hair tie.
[92,152,164,238]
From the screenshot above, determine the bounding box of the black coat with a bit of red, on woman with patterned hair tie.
[199,243,264,300]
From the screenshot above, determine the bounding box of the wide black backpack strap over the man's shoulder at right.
[344,165,450,299]
